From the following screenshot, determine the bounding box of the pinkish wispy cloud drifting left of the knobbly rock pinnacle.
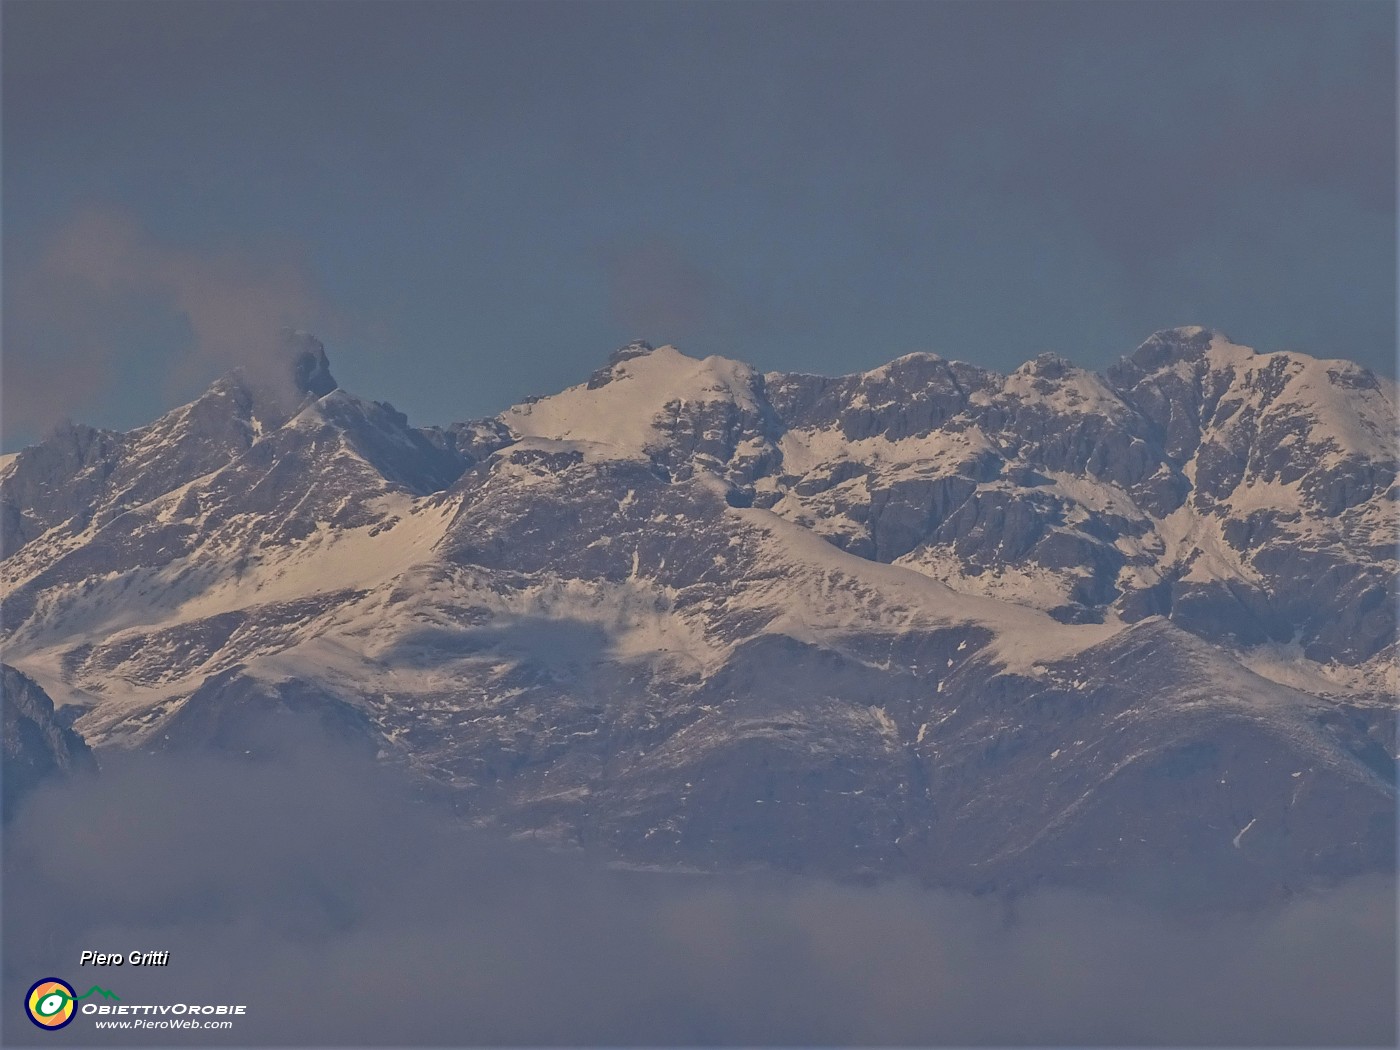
[3,207,336,445]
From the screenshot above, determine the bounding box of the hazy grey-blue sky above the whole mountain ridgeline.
[3,0,1396,447]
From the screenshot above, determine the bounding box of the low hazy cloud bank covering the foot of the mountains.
[4,734,1396,1046]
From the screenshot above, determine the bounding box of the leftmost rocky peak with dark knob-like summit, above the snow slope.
[0,333,462,582]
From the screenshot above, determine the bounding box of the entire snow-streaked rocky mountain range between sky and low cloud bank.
[0,329,1400,896]
